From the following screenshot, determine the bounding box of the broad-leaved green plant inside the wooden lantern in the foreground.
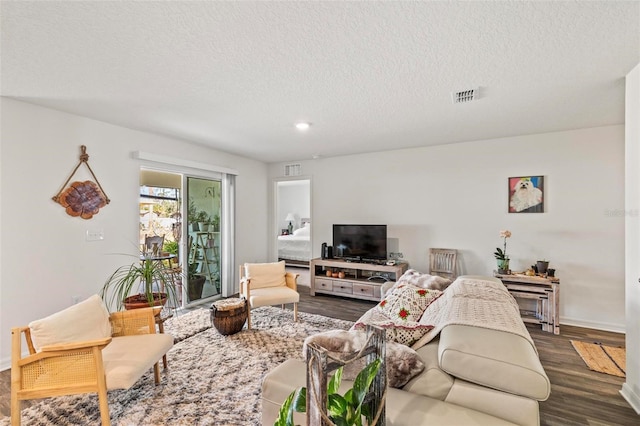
[274,358,382,426]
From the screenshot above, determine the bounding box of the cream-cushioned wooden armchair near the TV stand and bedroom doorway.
[240,261,300,329]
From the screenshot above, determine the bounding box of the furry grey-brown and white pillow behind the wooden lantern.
[302,330,424,388]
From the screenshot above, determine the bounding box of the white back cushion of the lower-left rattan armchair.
[29,294,111,350]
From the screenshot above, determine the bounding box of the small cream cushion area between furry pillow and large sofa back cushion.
[402,340,454,401]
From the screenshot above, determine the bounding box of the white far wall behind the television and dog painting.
[269,126,625,331]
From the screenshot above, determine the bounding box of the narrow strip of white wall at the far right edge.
[621,65,640,414]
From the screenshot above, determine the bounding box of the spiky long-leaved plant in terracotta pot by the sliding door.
[100,253,178,310]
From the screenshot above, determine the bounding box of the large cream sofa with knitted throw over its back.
[262,276,550,426]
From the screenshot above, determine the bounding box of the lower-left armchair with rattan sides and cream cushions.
[11,298,173,426]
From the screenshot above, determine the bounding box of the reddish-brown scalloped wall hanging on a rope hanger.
[52,145,111,219]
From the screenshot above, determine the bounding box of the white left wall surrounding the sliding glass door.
[0,98,269,368]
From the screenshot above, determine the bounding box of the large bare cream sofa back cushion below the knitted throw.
[438,325,551,401]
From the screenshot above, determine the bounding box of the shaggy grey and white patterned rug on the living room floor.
[0,307,353,426]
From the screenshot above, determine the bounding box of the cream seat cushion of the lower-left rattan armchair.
[102,333,173,389]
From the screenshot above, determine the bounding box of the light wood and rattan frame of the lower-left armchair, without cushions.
[11,308,162,426]
